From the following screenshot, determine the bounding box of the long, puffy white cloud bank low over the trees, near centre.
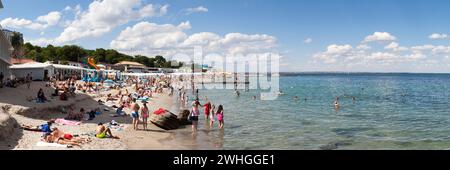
[110,22,276,56]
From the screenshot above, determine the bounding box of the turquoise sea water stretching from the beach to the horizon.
[194,74,450,149]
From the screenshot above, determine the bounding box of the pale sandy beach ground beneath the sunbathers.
[0,82,198,150]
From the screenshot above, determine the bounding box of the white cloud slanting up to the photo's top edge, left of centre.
[55,0,168,44]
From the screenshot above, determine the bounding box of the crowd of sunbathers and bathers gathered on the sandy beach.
[13,71,229,146]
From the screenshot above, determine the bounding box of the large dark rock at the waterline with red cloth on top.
[150,108,180,130]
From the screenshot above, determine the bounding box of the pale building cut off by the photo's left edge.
[0,0,14,82]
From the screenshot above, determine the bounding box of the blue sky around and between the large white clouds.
[0,0,450,72]
